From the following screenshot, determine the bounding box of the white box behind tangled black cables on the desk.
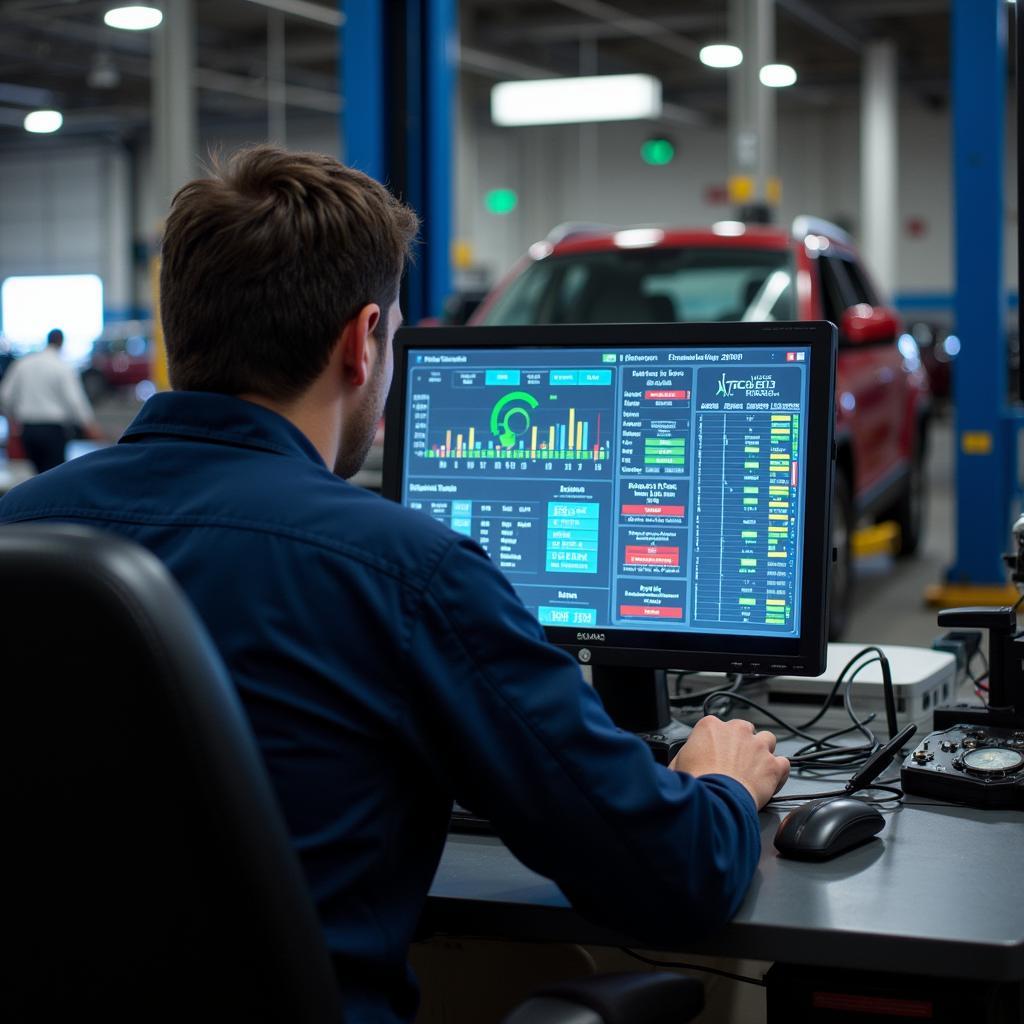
[753,643,957,735]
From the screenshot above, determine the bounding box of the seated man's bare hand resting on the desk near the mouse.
[669,715,790,810]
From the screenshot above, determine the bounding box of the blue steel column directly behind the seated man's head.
[340,0,457,324]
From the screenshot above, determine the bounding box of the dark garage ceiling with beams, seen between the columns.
[0,0,949,145]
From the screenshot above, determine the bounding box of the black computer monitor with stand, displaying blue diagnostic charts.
[383,323,836,731]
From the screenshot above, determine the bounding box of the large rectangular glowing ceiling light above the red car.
[490,75,662,128]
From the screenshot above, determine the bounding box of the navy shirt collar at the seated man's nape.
[118,391,325,466]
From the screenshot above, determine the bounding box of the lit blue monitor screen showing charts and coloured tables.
[401,345,811,637]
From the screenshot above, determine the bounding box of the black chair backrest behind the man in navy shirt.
[0,524,341,1024]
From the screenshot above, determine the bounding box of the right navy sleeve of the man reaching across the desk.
[409,541,761,943]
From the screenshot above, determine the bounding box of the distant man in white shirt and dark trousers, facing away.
[0,329,102,473]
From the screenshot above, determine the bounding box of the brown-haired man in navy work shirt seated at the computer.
[0,146,788,1022]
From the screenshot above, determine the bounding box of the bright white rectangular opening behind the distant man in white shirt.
[0,273,103,362]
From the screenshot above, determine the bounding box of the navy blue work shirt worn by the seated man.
[0,392,760,1022]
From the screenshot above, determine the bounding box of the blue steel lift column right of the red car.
[948,0,1016,585]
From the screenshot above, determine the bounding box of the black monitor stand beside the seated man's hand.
[591,665,690,765]
